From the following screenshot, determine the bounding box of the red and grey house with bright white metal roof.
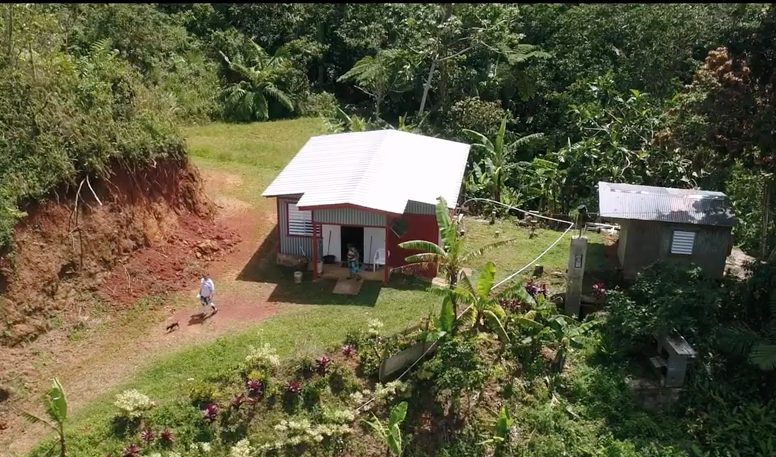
[262,130,470,281]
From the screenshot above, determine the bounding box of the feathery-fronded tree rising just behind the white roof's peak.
[338,49,417,119]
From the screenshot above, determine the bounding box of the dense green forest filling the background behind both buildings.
[0,4,776,254]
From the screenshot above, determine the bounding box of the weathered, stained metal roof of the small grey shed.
[598,182,735,227]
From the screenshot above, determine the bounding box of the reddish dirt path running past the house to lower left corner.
[0,170,282,457]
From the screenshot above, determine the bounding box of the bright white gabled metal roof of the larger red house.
[262,130,469,214]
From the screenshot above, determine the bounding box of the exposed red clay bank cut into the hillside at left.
[0,161,239,346]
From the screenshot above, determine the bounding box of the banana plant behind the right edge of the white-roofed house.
[463,117,544,203]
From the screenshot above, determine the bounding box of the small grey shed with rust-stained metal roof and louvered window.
[598,182,735,279]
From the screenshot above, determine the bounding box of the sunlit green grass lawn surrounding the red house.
[31,119,603,455]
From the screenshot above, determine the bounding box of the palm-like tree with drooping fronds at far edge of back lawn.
[219,40,298,121]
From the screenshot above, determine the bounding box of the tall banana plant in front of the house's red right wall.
[399,197,513,316]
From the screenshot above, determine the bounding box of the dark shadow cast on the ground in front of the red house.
[237,225,428,307]
